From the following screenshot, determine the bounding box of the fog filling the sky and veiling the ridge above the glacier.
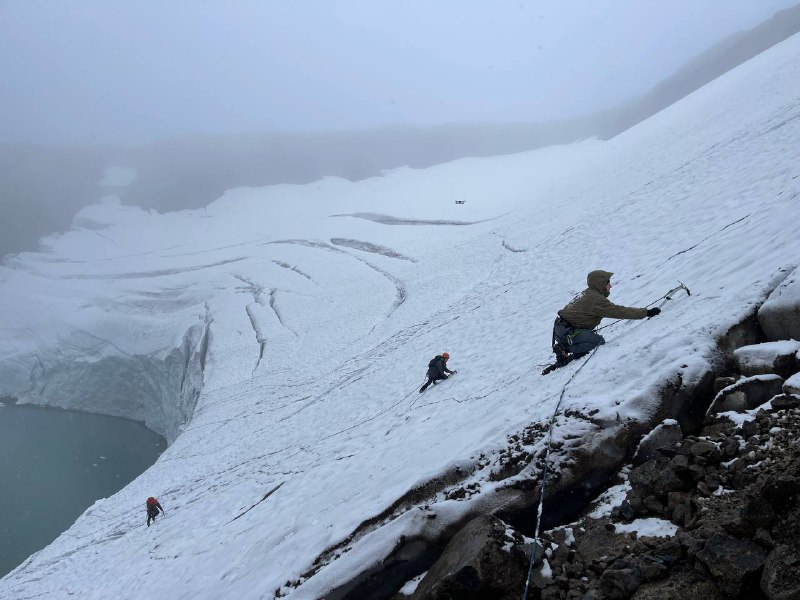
[0,0,800,255]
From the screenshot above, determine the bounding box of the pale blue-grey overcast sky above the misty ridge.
[0,0,798,143]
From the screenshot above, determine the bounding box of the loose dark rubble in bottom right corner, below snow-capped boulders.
[520,402,800,600]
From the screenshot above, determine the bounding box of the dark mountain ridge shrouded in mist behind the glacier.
[0,5,800,256]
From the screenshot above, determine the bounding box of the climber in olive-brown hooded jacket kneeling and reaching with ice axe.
[542,271,661,375]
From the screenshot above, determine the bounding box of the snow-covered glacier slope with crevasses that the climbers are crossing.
[0,36,800,599]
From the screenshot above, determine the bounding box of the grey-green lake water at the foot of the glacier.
[0,404,166,577]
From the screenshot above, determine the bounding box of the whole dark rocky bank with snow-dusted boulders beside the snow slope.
[397,288,800,600]
